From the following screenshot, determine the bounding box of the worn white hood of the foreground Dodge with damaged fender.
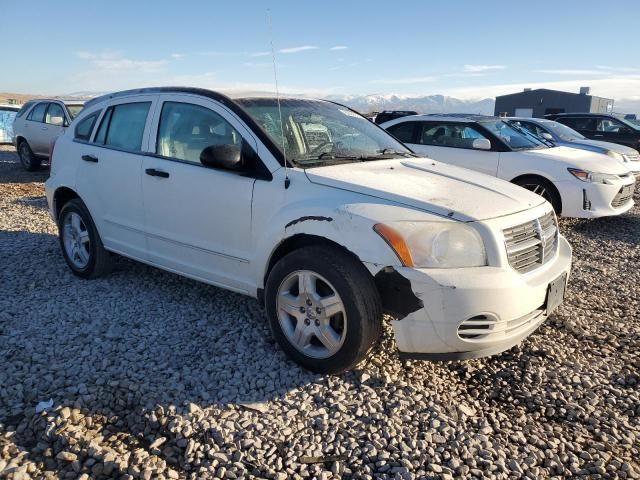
[305,158,544,222]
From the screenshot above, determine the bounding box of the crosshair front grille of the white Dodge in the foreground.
[502,212,558,273]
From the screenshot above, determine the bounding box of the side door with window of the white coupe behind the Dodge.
[409,122,500,176]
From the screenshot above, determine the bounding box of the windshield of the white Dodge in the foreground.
[237,98,413,168]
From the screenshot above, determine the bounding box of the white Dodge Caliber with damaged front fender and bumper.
[46,87,571,373]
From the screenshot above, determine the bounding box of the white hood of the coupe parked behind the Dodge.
[514,147,629,175]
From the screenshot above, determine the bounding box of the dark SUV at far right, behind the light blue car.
[545,113,640,152]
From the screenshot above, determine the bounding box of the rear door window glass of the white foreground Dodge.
[95,102,151,152]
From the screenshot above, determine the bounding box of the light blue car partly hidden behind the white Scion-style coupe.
[509,117,640,177]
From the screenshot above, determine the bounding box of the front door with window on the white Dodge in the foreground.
[142,94,259,292]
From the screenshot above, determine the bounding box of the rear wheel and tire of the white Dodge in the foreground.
[58,198,112,278]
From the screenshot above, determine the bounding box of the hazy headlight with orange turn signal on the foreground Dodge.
[373,222,487,268]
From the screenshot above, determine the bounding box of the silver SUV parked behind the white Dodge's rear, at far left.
[13,99,84,172]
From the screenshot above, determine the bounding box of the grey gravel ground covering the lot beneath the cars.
[0,143,640,479]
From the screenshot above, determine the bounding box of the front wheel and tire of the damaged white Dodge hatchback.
[265,246,382,374]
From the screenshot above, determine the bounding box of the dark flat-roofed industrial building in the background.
[495,87,613,118]
